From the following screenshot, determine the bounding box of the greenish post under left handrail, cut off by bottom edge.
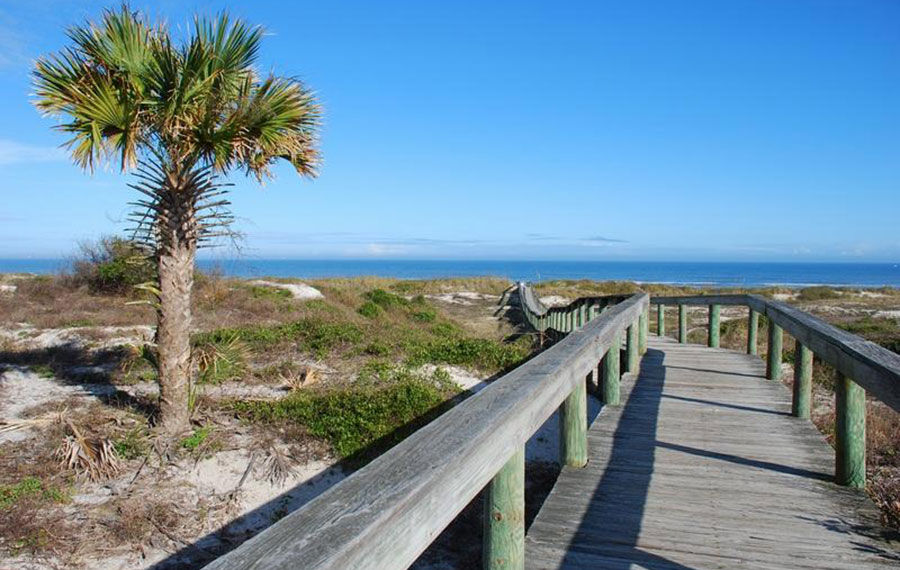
[482,447,525,570]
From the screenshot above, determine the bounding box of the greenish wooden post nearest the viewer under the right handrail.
[834,373,866,489]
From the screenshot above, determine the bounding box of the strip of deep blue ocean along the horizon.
[0,258,900,287]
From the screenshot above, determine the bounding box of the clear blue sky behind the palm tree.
[0,0,900,262]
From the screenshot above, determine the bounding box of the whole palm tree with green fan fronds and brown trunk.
[33,5,320,435]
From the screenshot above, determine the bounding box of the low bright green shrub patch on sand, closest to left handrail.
[234,370,447,459]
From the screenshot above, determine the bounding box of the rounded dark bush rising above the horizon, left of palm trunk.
[71,236,156,294]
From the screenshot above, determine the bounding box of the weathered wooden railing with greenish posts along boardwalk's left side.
[207,288,649,570]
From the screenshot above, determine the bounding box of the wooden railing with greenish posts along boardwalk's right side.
[651,295,900,488]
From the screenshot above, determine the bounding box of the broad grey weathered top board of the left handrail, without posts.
[206,293,649,570]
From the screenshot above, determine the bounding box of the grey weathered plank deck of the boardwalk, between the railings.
[525,337,900,570]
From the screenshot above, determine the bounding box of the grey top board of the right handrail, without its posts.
[650,294,900,412]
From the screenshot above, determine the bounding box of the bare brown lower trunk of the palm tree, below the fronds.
[157,236,196,435]
